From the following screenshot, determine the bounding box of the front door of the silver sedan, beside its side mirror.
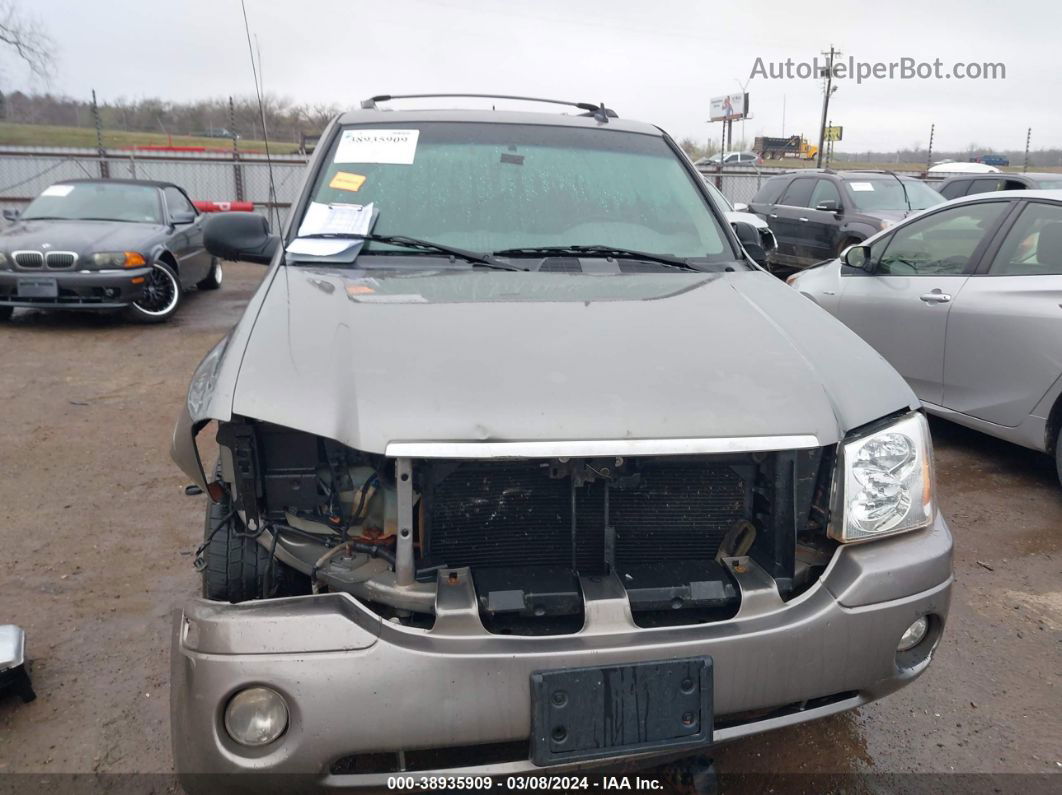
[838,201,1009,404]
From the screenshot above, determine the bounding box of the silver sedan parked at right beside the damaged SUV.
[789,190,1062,479]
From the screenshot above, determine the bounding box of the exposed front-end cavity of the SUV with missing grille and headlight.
[197,417,835,635]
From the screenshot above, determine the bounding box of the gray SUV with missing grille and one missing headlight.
[171,98,953,792]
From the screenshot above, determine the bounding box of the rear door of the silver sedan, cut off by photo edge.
[943,202,1062,427]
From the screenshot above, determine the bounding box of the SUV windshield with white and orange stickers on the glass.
[301,122,735,261]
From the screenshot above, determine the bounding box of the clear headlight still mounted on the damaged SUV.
[829,413,937,541]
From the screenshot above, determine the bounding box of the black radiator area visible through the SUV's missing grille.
[421,454,795,635]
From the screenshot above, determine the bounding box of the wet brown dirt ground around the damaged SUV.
[0,264,1062,792]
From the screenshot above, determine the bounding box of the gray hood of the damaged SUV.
[228,265,918,453]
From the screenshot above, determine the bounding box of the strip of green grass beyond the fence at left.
[0,122,298,154]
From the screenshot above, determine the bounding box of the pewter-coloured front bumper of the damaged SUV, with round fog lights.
[171,518,952,792]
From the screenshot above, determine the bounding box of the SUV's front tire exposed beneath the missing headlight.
[200,467,310,602]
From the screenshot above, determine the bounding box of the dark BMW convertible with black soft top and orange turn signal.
[0,179,221,323]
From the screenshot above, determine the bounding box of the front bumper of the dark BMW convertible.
[0,266,151,309]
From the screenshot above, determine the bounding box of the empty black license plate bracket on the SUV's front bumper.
[531,657,713,765]
